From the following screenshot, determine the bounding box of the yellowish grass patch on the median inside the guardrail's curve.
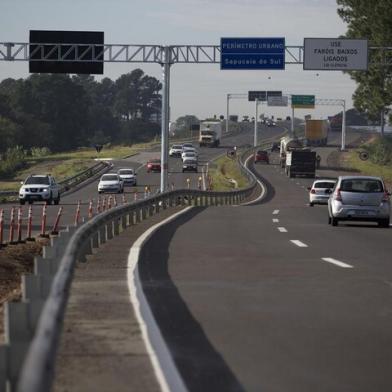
[208,155,248,191]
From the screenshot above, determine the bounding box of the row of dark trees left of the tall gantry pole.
[0,69,162,153]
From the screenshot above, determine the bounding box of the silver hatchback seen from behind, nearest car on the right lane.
[328,176,391,227]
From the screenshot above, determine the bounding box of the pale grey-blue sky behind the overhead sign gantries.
[0,0,355,121]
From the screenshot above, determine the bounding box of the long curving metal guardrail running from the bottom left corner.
[0,185,256,392]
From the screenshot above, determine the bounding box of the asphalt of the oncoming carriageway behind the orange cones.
[0,126,284,241]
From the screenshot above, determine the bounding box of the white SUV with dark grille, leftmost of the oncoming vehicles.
[19,174,60,205]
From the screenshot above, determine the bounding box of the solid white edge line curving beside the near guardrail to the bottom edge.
[127,207,193,392]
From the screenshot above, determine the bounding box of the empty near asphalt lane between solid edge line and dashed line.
[140,205,392,392]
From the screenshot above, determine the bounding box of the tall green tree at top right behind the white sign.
[337,0,392,134]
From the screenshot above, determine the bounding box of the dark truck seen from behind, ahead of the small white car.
[285,150,316,178]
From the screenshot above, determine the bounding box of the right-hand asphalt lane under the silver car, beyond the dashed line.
[251,153,392,272]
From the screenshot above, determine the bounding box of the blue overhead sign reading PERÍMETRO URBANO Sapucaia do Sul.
[221,38,285,70]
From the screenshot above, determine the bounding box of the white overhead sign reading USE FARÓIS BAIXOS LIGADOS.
[304,38,368,71]
